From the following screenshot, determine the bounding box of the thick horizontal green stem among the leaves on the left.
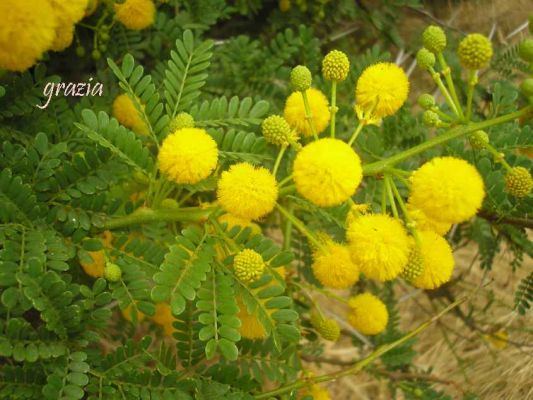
[102,207,216,230]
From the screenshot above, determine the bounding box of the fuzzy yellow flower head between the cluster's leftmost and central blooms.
[217,162,278,220]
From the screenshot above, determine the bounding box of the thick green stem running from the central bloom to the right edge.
[363,106,533,176]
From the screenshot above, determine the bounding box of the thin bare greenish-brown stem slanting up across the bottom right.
[255,296,469,400]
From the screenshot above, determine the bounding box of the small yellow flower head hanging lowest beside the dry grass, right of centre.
[348,293,389,335]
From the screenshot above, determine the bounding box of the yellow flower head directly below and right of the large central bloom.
[346,214,410,282]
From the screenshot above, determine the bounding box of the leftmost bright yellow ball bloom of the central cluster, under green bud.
[157,128,218,184]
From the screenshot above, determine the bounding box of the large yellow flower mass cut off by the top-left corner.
[0,0,57,71]
